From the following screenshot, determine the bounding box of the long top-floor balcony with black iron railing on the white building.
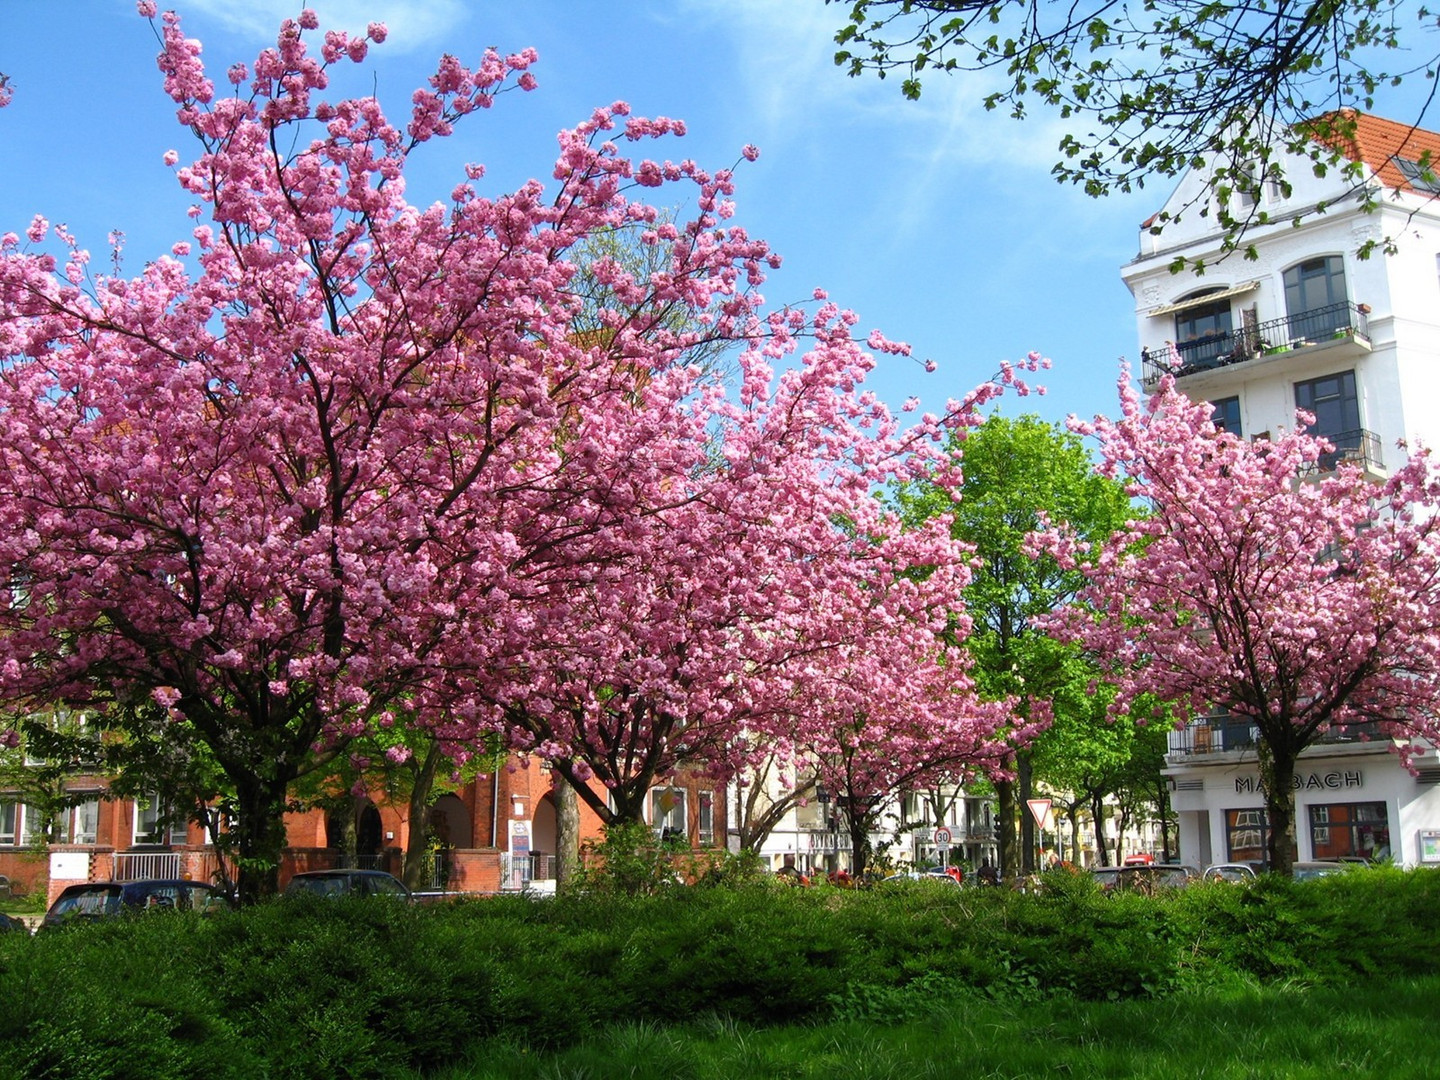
[1140,301,1369,390]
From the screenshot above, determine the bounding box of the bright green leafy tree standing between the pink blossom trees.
[896,415,1132,874]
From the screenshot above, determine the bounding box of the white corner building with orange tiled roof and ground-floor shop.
[1122,115,1440,865]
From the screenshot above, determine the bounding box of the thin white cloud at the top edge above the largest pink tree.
[176,0,468,53]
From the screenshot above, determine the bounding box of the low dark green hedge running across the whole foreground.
[0,870,1440,1080]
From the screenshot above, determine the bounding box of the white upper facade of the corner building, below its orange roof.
[1122,116,1440,472]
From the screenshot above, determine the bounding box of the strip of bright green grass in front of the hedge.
[433,978,1440,1080]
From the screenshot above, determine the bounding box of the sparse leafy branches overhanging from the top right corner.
[827,0,1437,256]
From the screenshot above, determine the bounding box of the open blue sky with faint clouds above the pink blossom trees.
[0,0,1347,432]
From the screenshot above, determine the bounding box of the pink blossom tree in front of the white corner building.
[1035,372,1440,873]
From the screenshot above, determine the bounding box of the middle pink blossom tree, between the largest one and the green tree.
[478,312,1038,822]
